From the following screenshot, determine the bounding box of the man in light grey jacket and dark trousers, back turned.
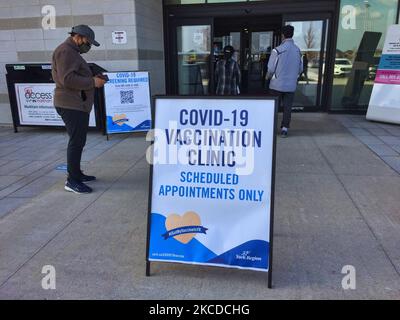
[267,25,303,138]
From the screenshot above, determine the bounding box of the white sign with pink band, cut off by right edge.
[367,24,400,124]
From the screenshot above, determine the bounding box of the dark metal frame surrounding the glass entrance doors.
[163,0,338,111]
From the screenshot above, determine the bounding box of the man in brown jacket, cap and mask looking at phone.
[52,25,105,194]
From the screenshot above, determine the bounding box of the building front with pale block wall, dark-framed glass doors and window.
[0,0,399,123]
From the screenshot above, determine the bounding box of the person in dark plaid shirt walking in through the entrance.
[215,46,240,96]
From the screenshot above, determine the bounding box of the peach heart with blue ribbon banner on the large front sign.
[162,211,208,244]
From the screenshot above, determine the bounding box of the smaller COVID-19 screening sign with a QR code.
[104,71,151,134]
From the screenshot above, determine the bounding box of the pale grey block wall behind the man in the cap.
[0,0,165,124]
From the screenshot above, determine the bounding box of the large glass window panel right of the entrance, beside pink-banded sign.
[332,0,398,110]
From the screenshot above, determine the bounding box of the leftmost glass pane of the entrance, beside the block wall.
[177,25,211,95]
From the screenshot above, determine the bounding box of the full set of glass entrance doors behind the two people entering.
[166,15,329,105]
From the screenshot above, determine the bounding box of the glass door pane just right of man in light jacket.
[284,20,327,108]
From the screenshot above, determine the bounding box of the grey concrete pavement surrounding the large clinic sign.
[0,114,400,299]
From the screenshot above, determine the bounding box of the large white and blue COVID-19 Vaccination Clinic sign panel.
[147,97,276,278]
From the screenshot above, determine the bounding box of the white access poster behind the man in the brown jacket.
[15,83,96,127]
